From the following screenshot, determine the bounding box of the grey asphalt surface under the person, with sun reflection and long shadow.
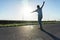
[0,24,60,40]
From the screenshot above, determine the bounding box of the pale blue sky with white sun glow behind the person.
[0,0,60,21]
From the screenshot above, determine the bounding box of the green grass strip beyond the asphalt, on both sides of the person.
[0,21,60,27]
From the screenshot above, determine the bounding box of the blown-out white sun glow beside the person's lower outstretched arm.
[21,5,33,20]
